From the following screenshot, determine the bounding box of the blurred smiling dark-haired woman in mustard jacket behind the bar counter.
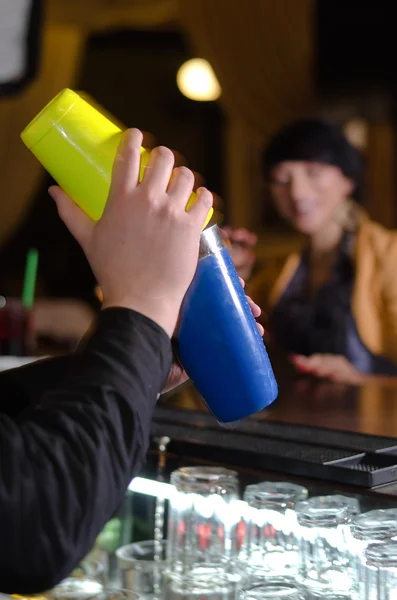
[228,118,397,384]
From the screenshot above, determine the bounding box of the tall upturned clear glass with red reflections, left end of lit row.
[167,467,241,592]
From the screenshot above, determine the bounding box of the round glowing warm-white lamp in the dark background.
[176,58,221,102]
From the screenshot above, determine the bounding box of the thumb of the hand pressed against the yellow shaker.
[48,186,95,250]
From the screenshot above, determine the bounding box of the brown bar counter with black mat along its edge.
[152,377,397,501]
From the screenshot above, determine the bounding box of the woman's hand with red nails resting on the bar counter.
[290,354,366,385]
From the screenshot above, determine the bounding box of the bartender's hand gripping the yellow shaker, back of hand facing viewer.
[50,129,212,337]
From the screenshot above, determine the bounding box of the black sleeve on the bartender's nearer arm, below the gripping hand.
[0,309,172,594]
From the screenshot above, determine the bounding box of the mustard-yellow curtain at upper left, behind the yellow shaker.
[0,0,178,246]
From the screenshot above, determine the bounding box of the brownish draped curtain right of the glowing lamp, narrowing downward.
[179,0,314,229]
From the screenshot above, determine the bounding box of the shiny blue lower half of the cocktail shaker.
[179,248,278,423]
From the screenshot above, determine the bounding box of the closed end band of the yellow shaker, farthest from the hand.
[21,89,79,150]
